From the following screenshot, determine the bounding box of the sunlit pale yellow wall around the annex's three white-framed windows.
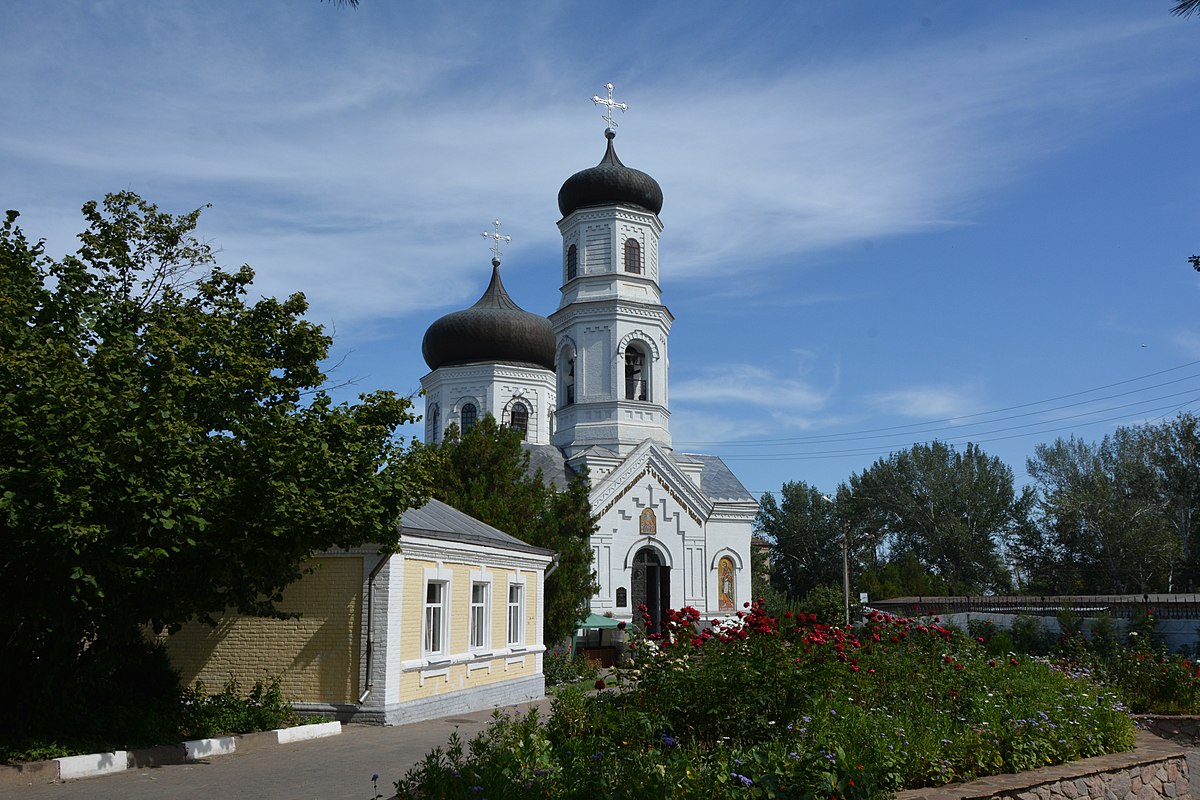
[400,559,540,699]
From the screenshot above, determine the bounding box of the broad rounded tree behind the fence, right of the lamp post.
[838,441,1033,594]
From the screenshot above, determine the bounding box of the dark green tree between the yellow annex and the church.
[431,414,599,644]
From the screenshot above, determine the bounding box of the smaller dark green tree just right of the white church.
[754,481,841,597]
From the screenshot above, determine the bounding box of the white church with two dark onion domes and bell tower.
[421,92,758,628]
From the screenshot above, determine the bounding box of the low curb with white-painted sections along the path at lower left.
[0,722,342,788]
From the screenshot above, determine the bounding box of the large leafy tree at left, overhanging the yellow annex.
[0,192,427,724]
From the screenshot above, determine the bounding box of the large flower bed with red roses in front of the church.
[396,606,1133,800]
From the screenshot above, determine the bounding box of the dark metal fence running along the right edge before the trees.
[865,594,1200,619]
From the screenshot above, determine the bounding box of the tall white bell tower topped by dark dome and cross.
[550,84,674,459]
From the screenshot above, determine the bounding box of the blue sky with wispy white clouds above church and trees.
[0,0,1200,501]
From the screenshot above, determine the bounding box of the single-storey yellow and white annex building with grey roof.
[167,500,554,724]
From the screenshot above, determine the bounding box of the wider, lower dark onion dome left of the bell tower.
[421,260,554,369]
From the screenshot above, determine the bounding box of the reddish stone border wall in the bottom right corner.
[895,730,1200,800]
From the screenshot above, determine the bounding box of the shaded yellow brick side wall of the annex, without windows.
[167,555,360,703]
